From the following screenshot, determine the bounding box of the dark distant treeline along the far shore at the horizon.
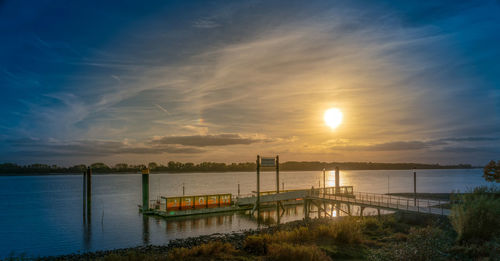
[0,161,474,174]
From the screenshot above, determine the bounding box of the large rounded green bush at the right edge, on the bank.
[450,187,500,242]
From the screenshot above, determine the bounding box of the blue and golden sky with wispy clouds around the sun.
[0,0,500,165]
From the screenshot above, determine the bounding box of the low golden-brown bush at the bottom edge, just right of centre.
[266,243,331,261]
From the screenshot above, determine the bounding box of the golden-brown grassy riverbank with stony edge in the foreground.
[32,212,458,261]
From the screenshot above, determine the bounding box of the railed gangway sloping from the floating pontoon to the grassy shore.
[308,188,450,215]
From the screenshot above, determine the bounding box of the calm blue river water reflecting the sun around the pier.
[0,169,487,258]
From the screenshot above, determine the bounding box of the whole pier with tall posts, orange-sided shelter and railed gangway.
[139,155,450,219]
